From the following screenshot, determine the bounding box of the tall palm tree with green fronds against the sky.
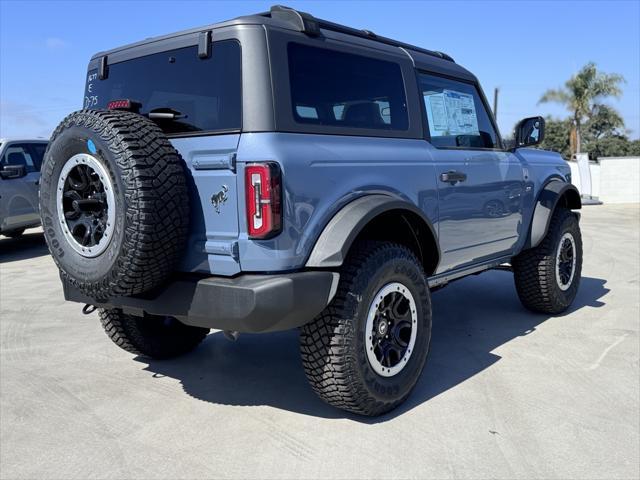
[538,62,625,153]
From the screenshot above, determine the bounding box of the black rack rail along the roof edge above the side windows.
[260,5,455,63]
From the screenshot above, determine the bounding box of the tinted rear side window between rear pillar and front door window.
[288,43,409,130]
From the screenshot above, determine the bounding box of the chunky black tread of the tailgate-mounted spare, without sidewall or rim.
[45,110,189,299]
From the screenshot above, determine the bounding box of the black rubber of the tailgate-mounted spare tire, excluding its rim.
[40,110,189,299]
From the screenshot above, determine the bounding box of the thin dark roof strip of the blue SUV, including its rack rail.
[91,5,455,63]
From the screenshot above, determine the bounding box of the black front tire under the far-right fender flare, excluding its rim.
[512,207,582,314]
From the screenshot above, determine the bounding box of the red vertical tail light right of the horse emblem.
[244,162,282,239]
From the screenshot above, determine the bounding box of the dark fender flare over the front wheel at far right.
[523,180,582,250]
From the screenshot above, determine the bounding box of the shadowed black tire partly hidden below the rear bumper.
[99,308,209,359]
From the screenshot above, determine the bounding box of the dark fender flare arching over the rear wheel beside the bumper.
[306,194,440,275]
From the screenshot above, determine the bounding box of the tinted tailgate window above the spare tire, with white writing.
[84,40,242,133]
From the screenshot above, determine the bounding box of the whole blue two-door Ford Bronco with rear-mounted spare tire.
[40,6,582,415]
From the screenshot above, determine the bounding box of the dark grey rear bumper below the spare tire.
[64,271,339,333]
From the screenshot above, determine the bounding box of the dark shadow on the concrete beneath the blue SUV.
[137,271,609,423]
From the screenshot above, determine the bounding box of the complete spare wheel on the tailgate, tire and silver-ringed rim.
[40,110,189,299]
